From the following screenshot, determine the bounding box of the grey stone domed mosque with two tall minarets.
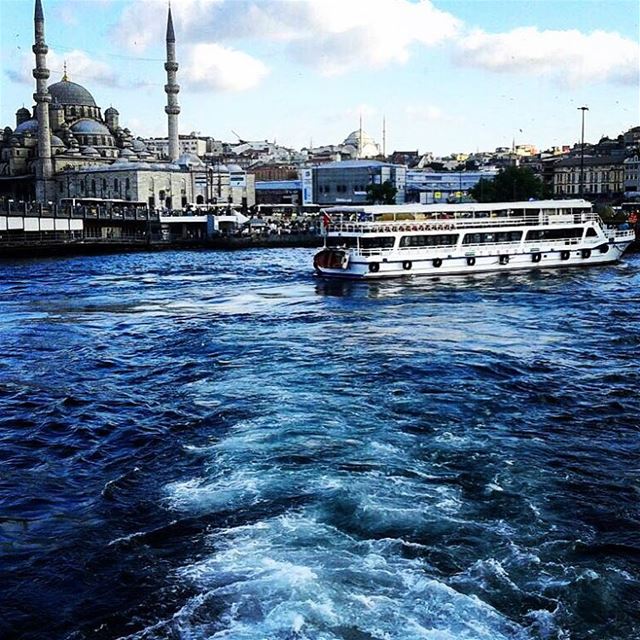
[0,0,238,209]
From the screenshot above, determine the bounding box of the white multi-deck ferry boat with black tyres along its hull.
[313,200,635,278]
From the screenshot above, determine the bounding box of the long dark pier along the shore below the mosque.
[0,199,322,258]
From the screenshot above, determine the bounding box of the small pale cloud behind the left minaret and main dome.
[5,49,118,87]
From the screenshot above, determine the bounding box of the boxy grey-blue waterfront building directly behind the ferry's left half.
[302,160,407,205]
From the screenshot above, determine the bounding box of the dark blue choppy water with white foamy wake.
[0,249,640,640]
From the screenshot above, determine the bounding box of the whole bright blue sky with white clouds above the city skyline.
[0,0,640,154]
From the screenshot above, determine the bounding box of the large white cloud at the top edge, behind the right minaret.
[114,0,461,75]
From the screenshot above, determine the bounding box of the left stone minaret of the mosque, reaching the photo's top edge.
[32,0,53,203]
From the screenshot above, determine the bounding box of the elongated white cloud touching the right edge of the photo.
[456,27,640,86]
